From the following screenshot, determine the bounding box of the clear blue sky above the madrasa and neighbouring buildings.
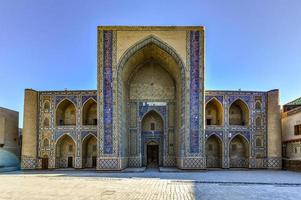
[0,0,301,127]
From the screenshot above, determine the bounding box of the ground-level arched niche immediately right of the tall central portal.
[206,135,223,168]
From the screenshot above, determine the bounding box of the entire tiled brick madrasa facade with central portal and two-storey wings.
[21,26,282,170]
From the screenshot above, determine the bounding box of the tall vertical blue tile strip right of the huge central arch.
[190,31,200,153]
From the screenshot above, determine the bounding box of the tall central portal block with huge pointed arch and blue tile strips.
[97,26,205,170]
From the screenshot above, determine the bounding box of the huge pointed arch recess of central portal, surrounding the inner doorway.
[117,36,186,167]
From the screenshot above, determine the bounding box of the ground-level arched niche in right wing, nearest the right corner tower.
[229,135,249,168]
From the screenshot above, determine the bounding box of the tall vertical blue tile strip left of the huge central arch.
[103,31,113,154]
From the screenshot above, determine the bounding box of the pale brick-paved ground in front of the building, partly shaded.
[0,170,301,200]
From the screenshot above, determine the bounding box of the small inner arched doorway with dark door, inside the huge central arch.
[141,111,164,167]
